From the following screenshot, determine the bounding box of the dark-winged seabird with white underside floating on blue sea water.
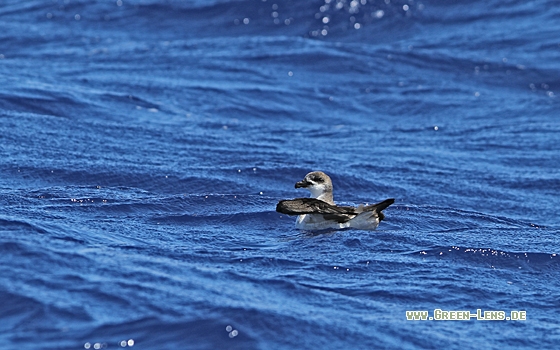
[276,171,395,231]
